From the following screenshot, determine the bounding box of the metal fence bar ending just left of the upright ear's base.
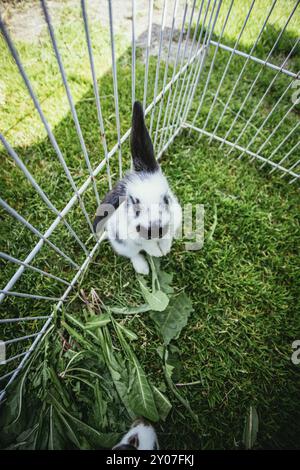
[108,0,123,178]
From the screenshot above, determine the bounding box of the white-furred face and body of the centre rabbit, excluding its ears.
[106,170,182,274]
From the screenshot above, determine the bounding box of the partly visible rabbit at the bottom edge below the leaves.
[113,418,159,450]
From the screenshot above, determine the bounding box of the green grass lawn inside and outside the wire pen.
[0,0,300,449]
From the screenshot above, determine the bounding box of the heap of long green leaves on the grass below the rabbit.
[0,259,192,449]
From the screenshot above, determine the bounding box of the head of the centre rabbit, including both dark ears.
[94,101,178,240]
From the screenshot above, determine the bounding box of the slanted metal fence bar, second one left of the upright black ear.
[81,0,112,189]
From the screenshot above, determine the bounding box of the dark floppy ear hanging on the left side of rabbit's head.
[93,180,126,233]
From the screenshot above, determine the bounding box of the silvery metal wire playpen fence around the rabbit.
[0,0,300,397]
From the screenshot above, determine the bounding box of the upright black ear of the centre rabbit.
[131,101,159,172]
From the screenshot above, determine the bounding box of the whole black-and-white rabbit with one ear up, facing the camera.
[94,101,182,274]
